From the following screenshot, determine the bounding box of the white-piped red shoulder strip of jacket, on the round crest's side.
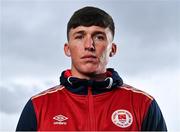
[119,84,154,101]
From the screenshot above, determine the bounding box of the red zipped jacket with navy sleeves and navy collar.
[16,69,167,131]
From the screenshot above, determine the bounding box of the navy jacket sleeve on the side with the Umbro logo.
[16,99,37,131]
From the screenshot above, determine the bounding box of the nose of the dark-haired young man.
[84,36,95,51]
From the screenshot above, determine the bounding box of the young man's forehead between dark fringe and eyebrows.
[69,26,111,36]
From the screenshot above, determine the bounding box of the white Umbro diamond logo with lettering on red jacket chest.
[53,115,68,125]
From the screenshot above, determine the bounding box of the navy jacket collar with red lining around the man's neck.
[60,68,123,95]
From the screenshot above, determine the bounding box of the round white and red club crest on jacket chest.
[111,110,133,128]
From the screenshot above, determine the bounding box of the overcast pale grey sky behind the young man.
[0,0,180,130]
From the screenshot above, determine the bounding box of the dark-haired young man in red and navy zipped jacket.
[16,7,167,131]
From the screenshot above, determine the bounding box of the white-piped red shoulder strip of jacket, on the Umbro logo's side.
[31,85,64,100]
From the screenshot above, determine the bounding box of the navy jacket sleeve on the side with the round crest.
[141,99,167,131]
